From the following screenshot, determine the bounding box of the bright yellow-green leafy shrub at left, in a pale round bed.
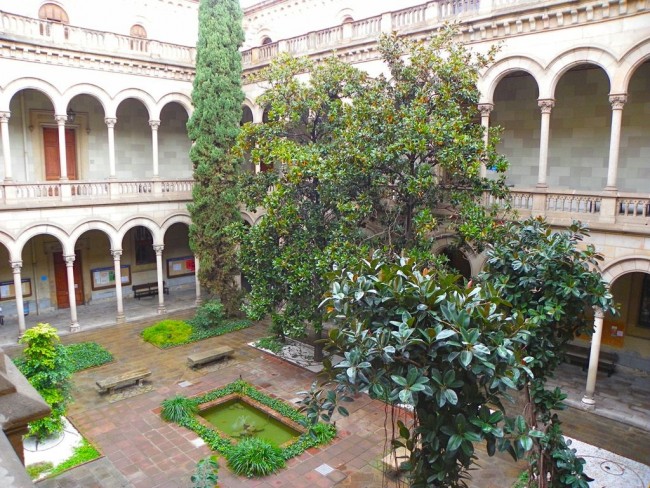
[19,323,72,439]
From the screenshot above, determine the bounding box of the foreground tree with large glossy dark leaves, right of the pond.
[305,254,525,487]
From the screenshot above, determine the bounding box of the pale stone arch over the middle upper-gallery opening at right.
[539,46,618,99]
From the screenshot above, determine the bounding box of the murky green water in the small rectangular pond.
[199,399,300,446]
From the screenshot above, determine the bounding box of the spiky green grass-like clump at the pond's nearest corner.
[227,437,284,478]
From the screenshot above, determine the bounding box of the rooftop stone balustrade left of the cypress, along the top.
[0,11,196,64]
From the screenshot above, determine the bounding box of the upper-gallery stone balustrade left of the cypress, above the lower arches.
[0,179,194,205]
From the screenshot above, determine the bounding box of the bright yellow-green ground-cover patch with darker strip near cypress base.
[142,319,252,349]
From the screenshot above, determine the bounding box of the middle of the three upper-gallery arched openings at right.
[548,64,612,190]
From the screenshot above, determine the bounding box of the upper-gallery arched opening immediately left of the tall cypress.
[158,102,192,178]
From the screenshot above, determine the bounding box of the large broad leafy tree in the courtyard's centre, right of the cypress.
[238,25,507,337]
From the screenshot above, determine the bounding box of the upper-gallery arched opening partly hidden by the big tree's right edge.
[488,71,540,188]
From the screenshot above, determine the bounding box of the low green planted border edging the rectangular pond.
[161,380,336,476]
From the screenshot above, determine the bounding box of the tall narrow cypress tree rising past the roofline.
[187,0,244,313]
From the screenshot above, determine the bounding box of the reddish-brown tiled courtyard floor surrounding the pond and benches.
[7,310,650,488]
